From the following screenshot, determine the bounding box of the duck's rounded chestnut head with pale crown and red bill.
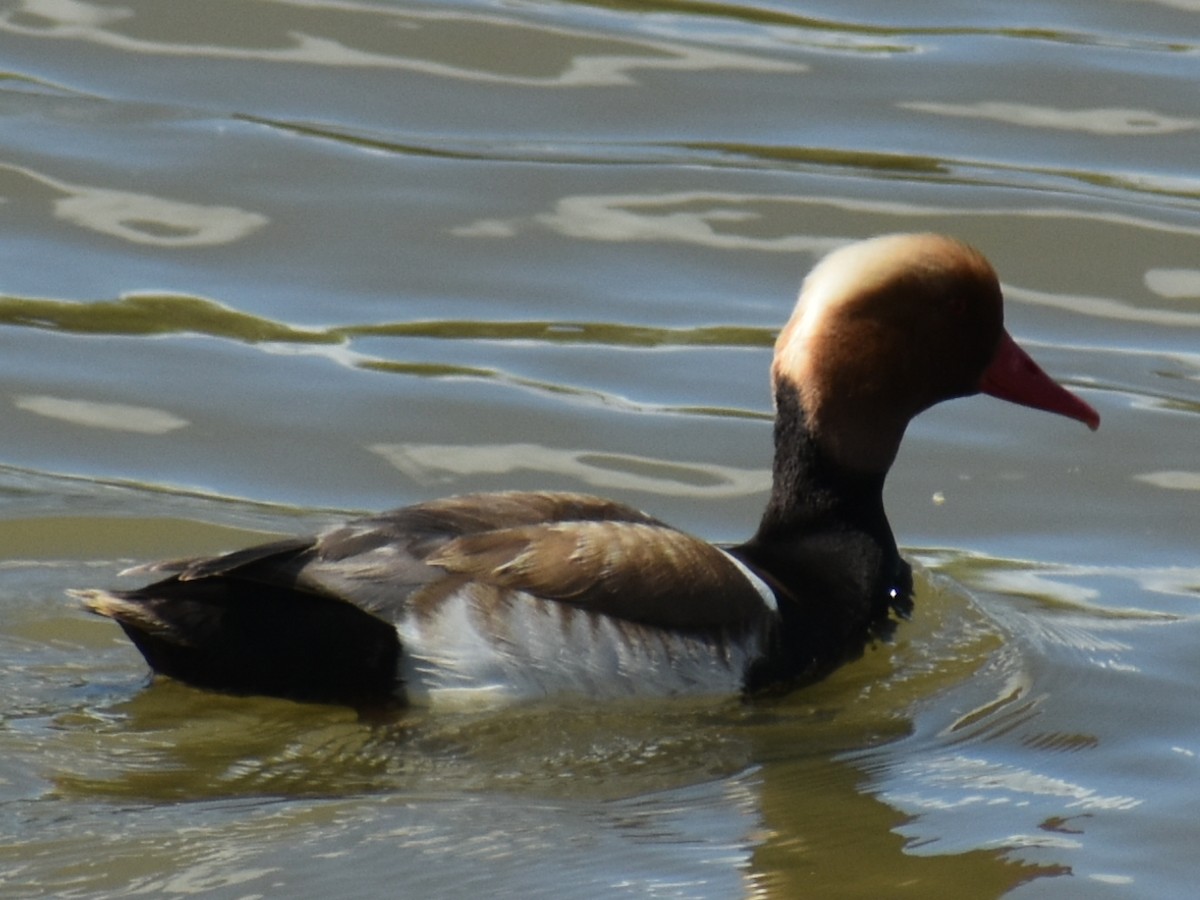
[772,234,1100,474]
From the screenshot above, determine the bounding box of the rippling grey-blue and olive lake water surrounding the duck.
[0,0,1200,898]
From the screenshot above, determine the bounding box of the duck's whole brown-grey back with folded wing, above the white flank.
[93,492,764,643]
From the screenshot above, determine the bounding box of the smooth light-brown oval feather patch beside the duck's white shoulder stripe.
[426,521,764,629]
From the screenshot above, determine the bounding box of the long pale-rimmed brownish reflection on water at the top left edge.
[0,0,808,88]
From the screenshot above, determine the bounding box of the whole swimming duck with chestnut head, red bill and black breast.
[73,234,1099,707]
